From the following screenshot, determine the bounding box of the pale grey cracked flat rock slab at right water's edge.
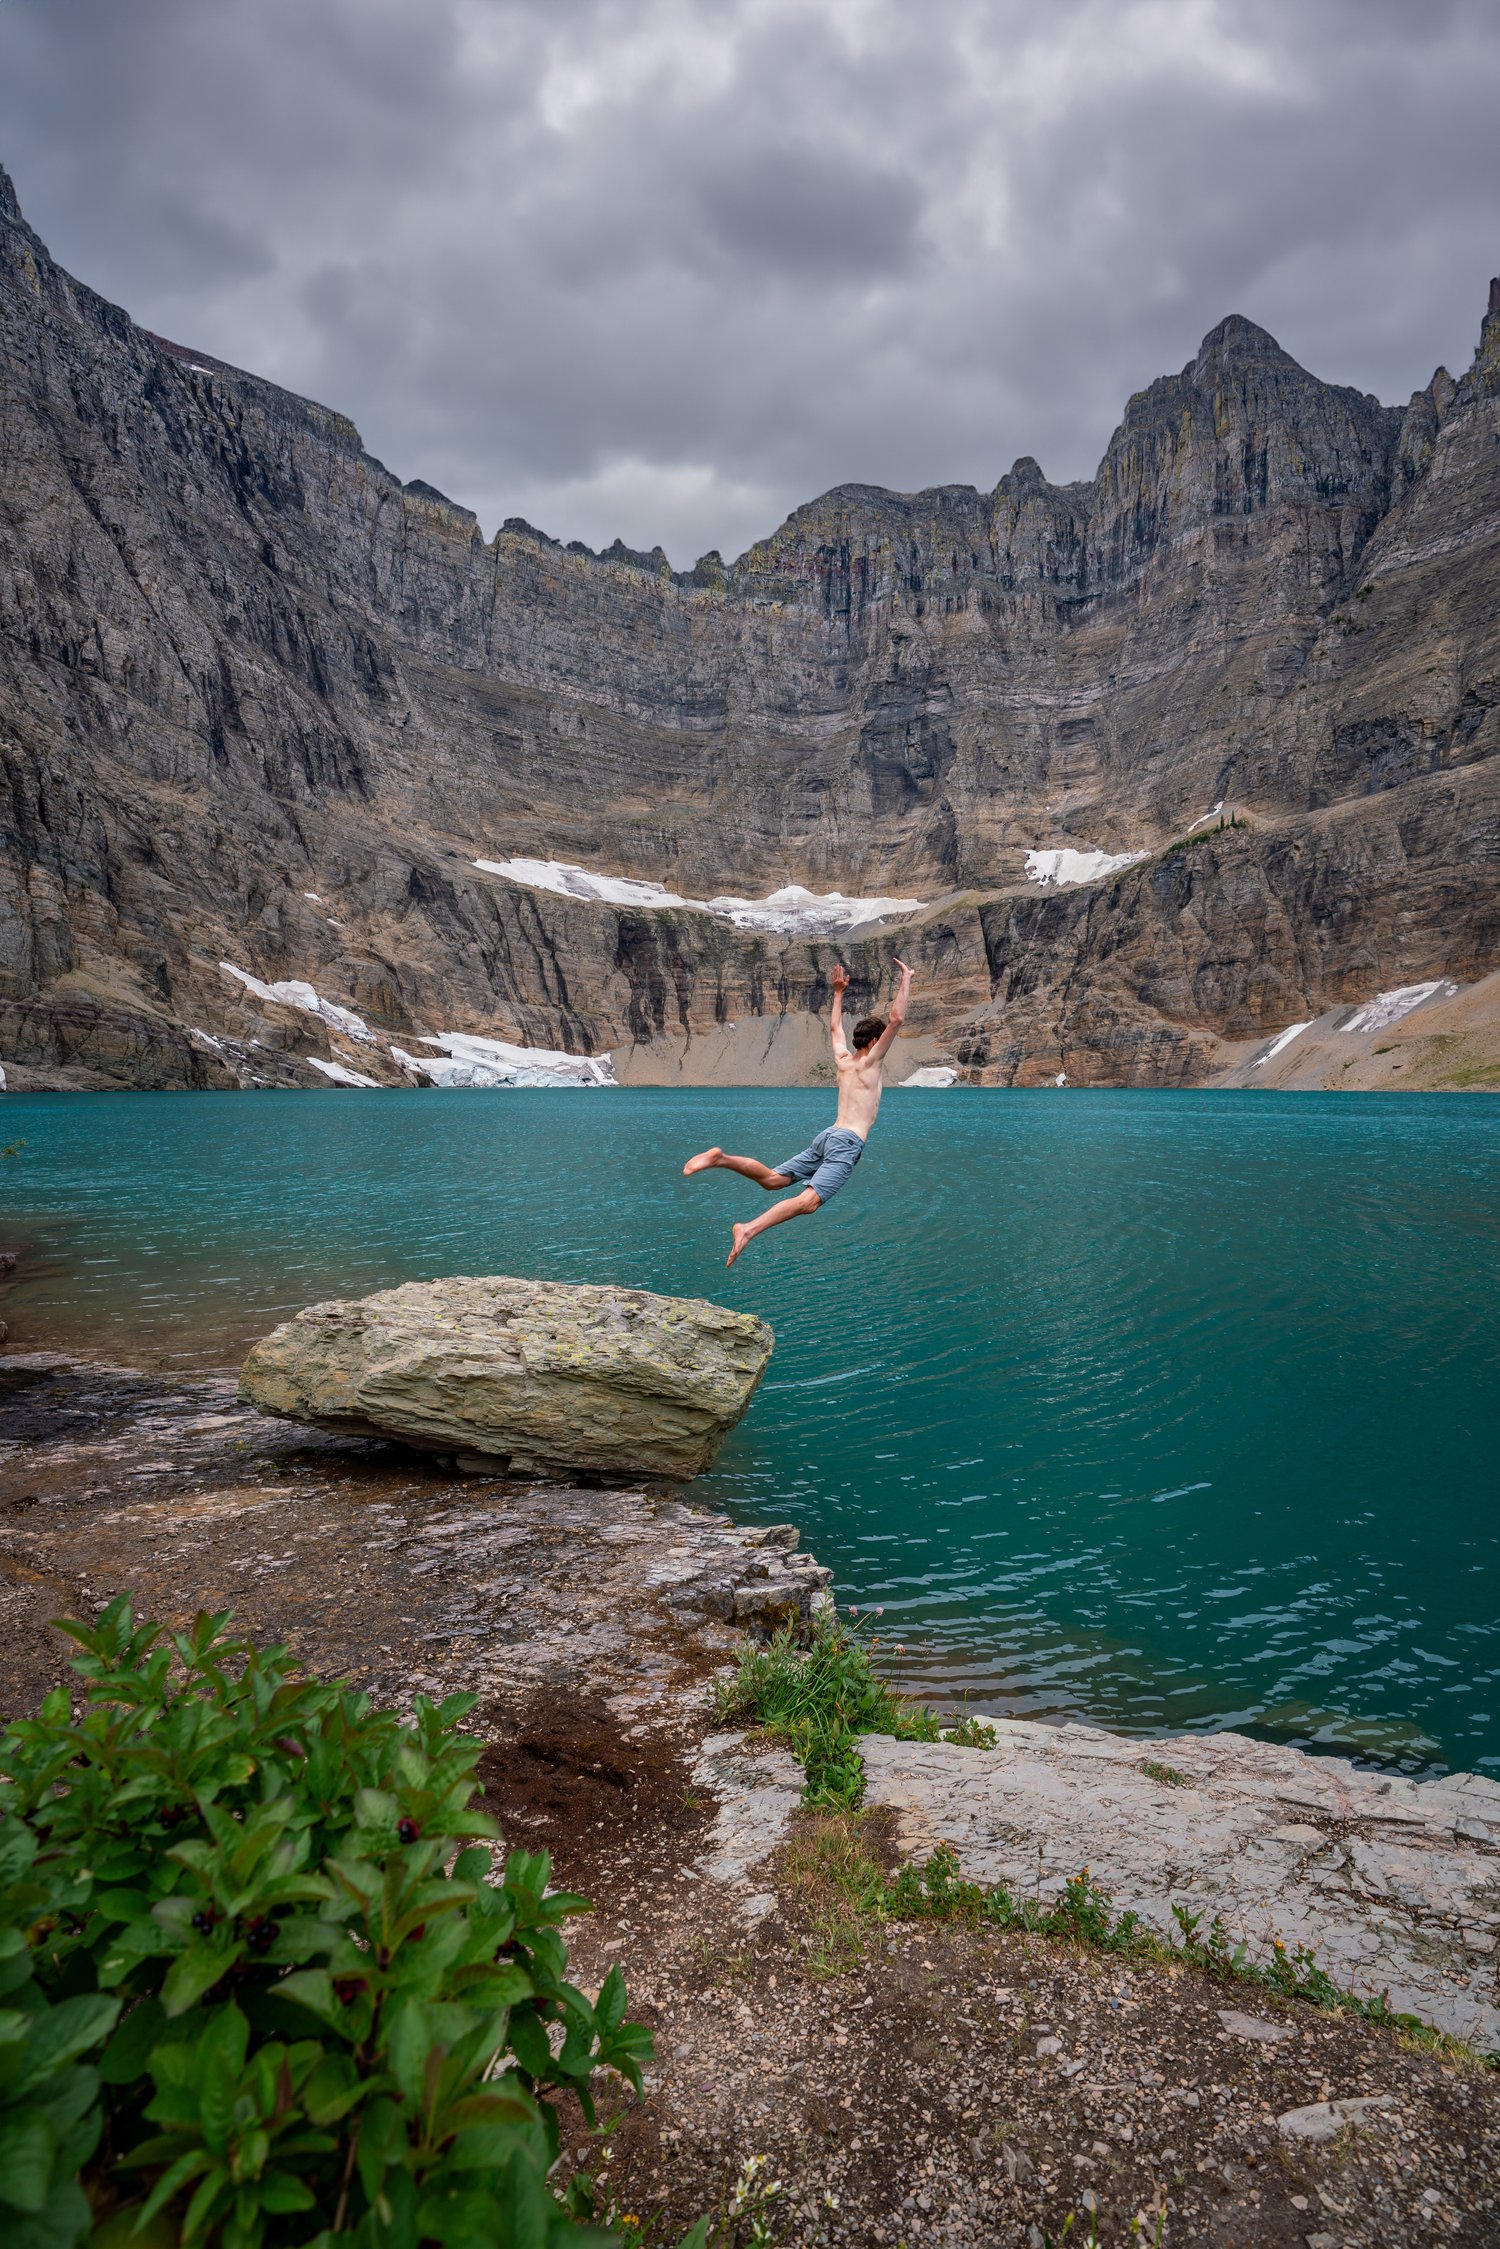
[859,1720,1500,2051]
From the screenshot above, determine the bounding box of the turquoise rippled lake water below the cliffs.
[0,1089,1500,1772]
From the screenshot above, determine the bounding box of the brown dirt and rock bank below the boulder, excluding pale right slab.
[0,1361,1500,2249]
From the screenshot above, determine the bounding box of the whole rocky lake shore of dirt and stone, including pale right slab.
[0,1354,1500,2249]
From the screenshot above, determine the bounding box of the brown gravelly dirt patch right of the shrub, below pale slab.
[526,1718,1500,2249]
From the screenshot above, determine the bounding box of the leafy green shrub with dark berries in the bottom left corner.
[0,1599,650,2249]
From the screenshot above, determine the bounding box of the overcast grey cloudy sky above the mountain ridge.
[0,0,1500,564]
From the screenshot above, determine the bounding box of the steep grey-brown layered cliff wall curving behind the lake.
[0,154,1500,1084]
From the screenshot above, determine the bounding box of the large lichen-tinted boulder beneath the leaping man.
[241,1275,776,1482]
